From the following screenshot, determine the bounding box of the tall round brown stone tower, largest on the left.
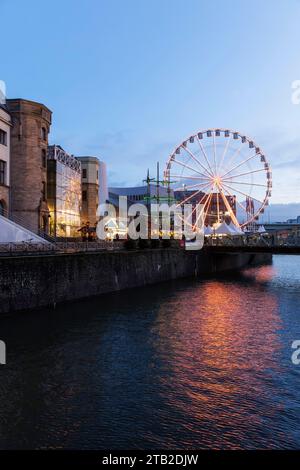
[6,99,52,233]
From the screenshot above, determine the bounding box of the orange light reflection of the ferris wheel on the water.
[155,267,281,448]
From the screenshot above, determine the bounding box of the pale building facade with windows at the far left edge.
[0,104,12,216]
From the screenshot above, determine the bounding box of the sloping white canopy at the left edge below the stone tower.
[0,215,49,245]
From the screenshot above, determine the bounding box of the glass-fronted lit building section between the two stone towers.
[47,145,81,237]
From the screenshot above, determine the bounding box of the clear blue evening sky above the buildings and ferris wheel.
[0,0,300,203]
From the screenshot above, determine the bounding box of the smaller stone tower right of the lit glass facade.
[76,157,100,226]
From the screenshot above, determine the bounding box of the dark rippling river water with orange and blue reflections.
[0,256,300,449]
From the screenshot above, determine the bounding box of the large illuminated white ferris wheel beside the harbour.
[164,129,272,228]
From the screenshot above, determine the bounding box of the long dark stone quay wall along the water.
[0,249,272,314]
